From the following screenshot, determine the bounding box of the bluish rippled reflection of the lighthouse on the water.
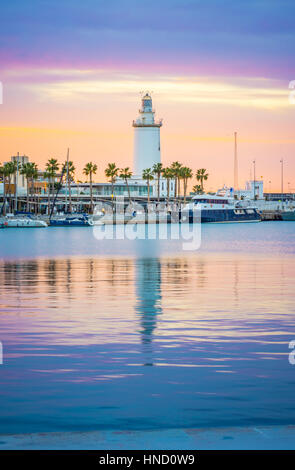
[135,258,162,365]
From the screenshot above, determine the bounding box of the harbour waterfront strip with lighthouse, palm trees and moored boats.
[0,92,295,228]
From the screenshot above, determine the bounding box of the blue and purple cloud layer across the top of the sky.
[0,0,295,80]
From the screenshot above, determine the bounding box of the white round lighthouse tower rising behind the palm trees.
[132,93,162,178]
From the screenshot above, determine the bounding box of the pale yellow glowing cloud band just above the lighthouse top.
[6,69,290,109]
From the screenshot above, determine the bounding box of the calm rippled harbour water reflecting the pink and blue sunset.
[0,222,295,433]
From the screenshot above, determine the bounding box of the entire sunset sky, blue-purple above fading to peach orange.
[0,0,295,191]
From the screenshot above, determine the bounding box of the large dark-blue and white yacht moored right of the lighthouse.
[180,192,261,223]
